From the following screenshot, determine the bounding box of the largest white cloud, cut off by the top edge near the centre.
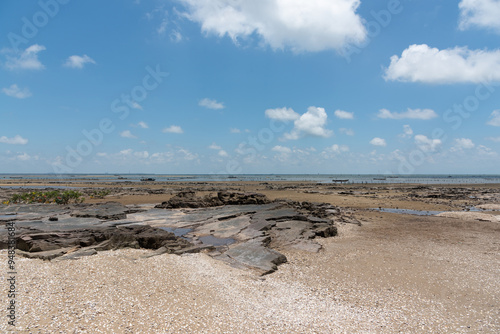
[180,0,367,52]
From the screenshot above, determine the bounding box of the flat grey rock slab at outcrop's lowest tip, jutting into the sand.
[224,242,287,275]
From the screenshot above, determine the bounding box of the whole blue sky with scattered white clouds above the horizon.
[0,0,500,174]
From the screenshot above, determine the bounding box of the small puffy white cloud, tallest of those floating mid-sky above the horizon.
[283,107,333,140]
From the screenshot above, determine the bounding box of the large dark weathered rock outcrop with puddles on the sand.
[0,191,342,275]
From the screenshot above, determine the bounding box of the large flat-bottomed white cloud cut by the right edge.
[384,44,500,84]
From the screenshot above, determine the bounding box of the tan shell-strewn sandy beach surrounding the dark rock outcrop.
[0,182,500,333]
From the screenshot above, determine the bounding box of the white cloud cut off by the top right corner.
[458,0,500,33]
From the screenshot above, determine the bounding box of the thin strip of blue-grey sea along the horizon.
[0,174,500,186]
